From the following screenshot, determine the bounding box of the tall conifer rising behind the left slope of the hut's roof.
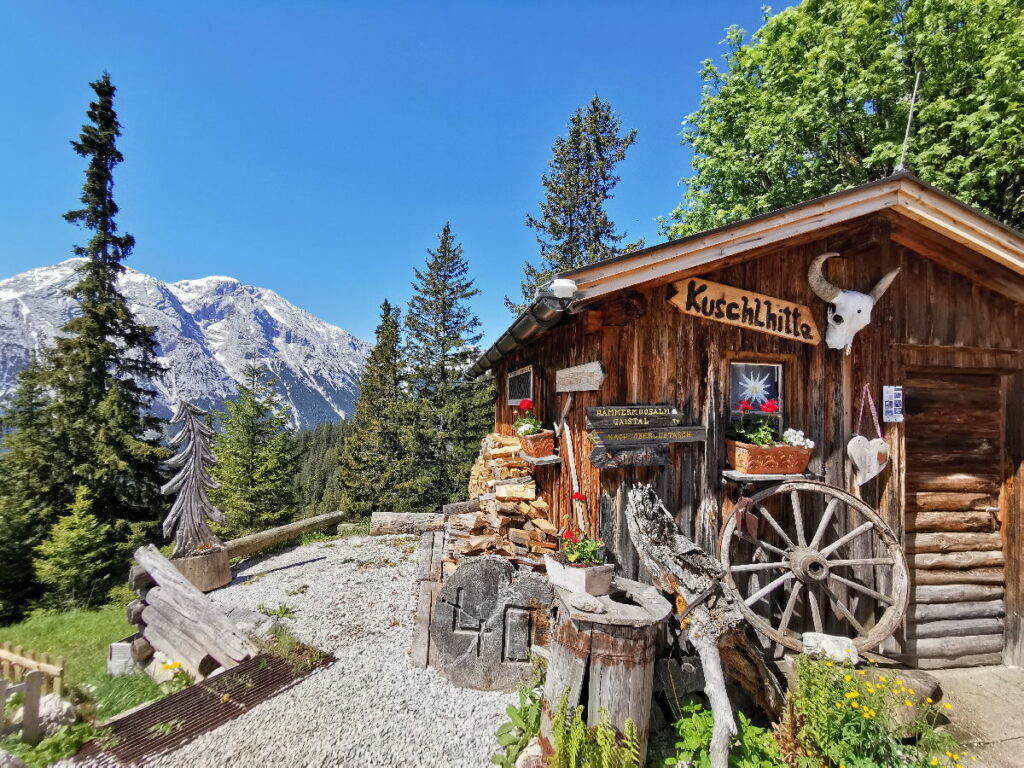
[505,95,643,313]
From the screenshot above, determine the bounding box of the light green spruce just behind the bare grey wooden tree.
[209,362,297,537]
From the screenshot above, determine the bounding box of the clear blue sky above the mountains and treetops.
[0,0,761,341]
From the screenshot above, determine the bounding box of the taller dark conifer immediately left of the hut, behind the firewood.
[404,223,494,509]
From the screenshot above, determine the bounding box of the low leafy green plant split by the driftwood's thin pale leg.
[665,702,785,768]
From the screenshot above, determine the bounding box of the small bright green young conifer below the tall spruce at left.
[34,485,113,607]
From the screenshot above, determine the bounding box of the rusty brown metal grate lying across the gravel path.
[75,653,334,768]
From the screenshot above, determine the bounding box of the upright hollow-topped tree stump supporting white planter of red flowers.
[541,577,672,765]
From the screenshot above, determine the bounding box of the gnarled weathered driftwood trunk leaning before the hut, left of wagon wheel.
[626,483,782,768]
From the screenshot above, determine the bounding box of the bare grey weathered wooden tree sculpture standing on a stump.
[160,402,224,557]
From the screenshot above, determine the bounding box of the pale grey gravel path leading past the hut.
[148,537,515,768]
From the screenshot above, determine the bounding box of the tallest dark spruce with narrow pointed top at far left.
[0,74,166,618]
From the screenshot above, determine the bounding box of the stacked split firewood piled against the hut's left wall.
[445,434,558,567]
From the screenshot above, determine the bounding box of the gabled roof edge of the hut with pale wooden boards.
[466,173,1024,379]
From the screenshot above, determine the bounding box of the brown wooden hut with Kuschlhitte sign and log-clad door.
[467,174,1024,668]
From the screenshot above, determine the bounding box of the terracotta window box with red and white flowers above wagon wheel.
[725,399,814,475]
